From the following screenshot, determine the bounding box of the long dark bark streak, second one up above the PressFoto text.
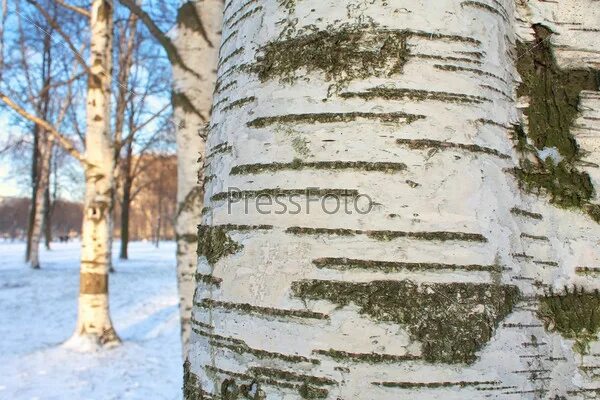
[246,112,425,128]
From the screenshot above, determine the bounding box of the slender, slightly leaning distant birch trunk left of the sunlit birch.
[29,131,53,269]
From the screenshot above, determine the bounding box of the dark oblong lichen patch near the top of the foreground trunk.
[252,26,409,82]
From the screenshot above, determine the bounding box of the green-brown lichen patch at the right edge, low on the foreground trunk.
[538,288,600,354]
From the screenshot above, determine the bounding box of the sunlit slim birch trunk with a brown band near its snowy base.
[74,0,119,346]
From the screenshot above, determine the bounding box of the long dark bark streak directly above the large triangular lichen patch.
[313,257,505,272]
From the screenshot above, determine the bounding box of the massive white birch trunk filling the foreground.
[184,0,600,400]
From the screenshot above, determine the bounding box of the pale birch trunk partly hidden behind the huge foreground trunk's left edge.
[173,0,223,354]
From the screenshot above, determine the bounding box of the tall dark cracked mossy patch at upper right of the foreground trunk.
[515,25,600,222]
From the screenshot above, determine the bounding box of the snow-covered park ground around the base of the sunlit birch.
[0,242,182,400]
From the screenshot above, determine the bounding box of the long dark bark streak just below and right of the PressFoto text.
[286,226,487,243]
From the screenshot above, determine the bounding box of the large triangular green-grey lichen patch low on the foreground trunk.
[292,280,519,363]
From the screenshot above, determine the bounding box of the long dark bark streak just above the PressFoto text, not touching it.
[230,160,407,175]
